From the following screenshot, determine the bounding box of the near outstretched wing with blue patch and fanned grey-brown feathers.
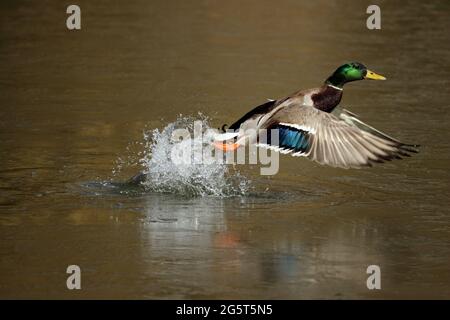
[258,105,418,168]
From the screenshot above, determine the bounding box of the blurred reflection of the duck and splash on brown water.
[137,197,338,297]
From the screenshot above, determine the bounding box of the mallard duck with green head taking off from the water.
[214,62,418,168]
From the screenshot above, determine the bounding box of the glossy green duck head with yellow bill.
[325,62,386,88]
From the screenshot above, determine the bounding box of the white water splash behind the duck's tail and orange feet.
[139,116,250,197]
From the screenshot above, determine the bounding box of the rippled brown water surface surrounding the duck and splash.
[0,0,450,299]
